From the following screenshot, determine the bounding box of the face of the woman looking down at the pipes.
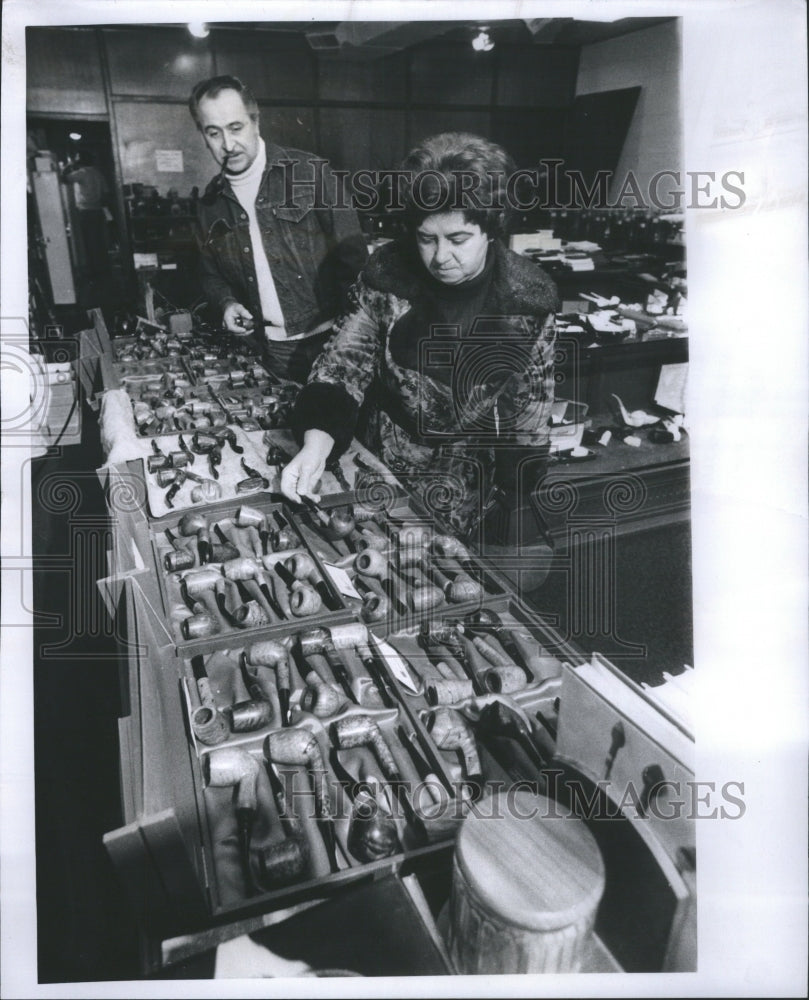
[416,212,489,285]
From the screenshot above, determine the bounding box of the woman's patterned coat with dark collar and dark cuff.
[293,241,558,534]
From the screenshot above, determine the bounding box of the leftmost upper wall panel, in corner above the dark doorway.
[25,28,107,115]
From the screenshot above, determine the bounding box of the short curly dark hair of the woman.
[402,132,515,238]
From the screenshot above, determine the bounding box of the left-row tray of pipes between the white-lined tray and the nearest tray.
[150,494,350,648]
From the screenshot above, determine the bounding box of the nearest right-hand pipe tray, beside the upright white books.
[364,598,582,797]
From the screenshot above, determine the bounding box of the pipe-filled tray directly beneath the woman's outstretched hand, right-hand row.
[288,494,507,630]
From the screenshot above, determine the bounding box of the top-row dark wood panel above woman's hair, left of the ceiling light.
[410,42,494,105]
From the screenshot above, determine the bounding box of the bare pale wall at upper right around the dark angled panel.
[576,21,682,195]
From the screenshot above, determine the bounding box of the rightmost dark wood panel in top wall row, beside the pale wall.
[495,45,579,108]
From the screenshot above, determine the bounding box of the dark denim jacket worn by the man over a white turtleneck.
[197,142,368,336]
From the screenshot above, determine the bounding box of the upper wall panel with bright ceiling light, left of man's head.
[104,28,213,100]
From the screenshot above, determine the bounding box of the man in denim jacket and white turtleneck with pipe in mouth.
[189,76,367,383]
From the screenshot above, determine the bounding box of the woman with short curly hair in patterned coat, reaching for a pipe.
[281,132,558,537]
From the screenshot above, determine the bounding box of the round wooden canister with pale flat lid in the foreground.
[447,792,604,975]
